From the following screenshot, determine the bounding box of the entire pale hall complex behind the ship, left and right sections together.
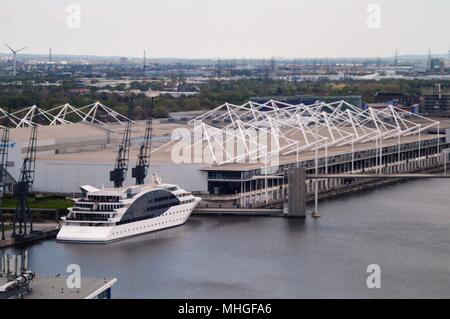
[0,100,450,211]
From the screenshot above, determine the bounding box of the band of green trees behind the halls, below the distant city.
[0,79,450,119]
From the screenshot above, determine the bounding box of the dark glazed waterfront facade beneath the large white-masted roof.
[205,134,450,195]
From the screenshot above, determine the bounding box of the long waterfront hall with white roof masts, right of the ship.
[169,100,448,206]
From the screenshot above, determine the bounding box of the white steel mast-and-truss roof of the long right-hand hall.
[180,100,439,165]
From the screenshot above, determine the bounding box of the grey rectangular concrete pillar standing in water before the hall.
[288,168,306,218]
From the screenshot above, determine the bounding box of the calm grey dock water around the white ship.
[0,179,450,298]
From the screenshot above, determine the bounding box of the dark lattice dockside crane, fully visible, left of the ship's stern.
[12,125,37,238]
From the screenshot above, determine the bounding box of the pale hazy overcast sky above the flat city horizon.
[0,0,450,58]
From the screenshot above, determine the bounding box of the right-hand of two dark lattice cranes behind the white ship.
[131,98,153,185]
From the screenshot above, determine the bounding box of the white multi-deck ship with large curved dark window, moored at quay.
[56,179,201,243]
